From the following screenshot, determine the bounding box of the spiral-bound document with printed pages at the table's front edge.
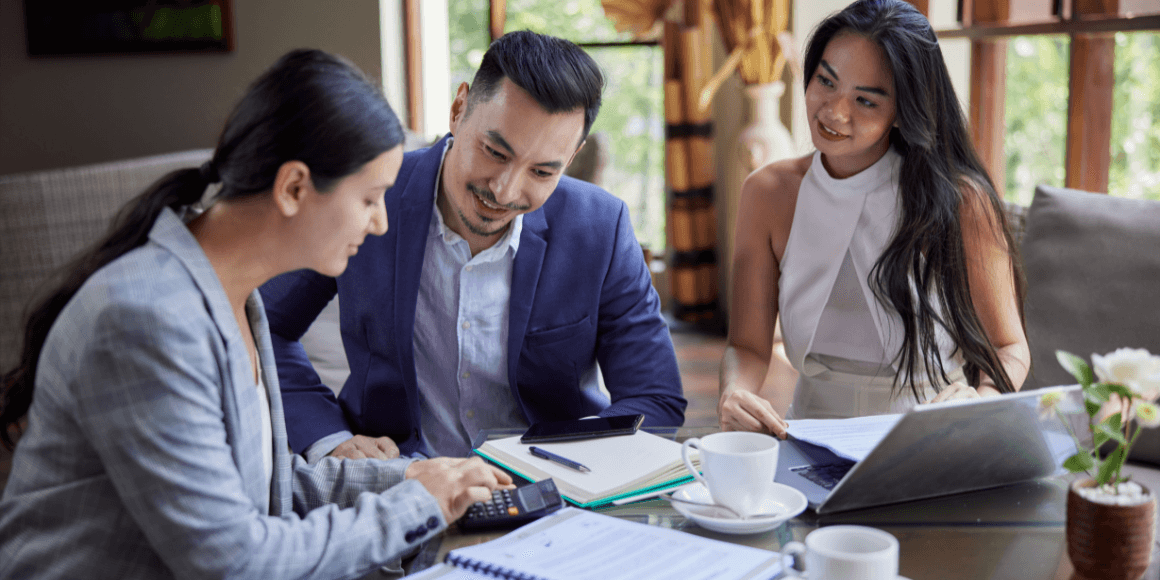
[407,507,781,580]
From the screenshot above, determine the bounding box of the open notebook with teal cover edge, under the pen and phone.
[476,430,699,507]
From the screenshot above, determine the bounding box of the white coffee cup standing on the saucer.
[681,432,778,517]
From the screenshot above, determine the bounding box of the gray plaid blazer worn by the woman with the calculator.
[0,210,447,579]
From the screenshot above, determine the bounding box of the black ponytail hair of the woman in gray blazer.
[0,50,404,449]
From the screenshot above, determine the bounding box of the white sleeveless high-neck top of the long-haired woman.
[778,148,962,419]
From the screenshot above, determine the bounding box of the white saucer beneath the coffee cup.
[672,483,807,534]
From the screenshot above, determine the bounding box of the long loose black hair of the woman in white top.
[805,0,1025,399]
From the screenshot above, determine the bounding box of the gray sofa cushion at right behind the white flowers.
[1022,186,1160,462]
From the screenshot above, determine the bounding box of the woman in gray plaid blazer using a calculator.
[0,51,510,579]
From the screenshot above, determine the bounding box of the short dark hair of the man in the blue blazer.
[466,30,604,142]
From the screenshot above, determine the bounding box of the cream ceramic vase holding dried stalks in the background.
[738,80,796,173]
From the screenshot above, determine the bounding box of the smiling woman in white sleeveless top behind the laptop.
[718,0,1030,436]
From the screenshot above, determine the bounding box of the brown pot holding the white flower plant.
[1067,479,1157,580]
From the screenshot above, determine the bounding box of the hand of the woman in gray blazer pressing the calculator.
[406,457,515,523]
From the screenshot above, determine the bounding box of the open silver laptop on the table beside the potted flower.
[776,385,1081,514]
